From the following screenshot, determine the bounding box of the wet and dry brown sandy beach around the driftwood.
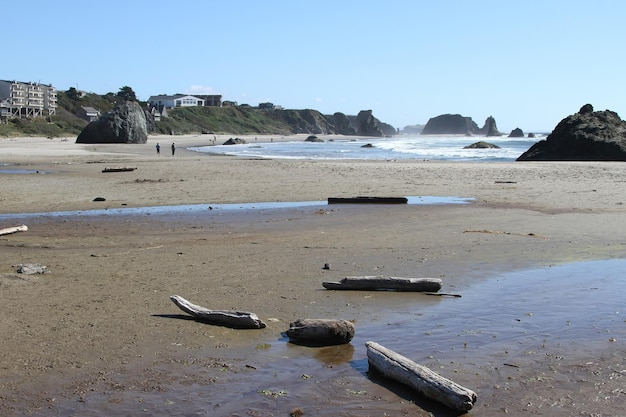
[0,135,626,416]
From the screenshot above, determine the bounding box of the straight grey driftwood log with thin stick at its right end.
[322,276,441,292]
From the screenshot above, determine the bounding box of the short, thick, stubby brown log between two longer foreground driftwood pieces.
[286,319,354,346]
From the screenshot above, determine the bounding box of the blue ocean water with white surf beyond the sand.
[189,135,545,162]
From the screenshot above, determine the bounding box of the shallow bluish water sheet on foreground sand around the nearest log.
[46,260,626,416]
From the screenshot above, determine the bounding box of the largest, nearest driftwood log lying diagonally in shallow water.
[365,342,476,411]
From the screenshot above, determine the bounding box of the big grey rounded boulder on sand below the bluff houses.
[76,101,148,143]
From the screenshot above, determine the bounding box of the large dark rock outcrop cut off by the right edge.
[517,104,626,161]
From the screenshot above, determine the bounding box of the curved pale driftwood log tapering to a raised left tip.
[170,295,265,329]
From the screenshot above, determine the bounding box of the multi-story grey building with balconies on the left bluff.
[0,80,57,119]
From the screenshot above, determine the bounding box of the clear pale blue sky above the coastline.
[6,0,626,133]
